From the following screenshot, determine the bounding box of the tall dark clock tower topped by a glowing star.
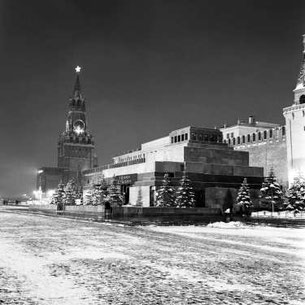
[57,67,95,178]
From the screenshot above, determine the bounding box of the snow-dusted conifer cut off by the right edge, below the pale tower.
[284,177,305,213]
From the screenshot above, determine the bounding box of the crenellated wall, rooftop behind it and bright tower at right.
[220,35,305,187]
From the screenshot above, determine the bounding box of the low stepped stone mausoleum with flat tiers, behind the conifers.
[83,127,263,208]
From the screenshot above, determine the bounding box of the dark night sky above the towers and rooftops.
[0,0,305,196]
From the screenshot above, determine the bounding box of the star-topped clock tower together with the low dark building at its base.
[37,67,97,193]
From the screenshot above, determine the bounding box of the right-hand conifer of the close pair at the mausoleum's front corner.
[175,173,195,208]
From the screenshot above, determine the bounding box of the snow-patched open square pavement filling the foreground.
[0,210,305,305]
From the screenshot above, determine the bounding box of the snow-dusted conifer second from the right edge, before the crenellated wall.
[260,169,283,212]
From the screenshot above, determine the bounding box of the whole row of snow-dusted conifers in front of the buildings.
[52,170,305,214]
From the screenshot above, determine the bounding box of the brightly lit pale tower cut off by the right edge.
[283,35,305,184]
